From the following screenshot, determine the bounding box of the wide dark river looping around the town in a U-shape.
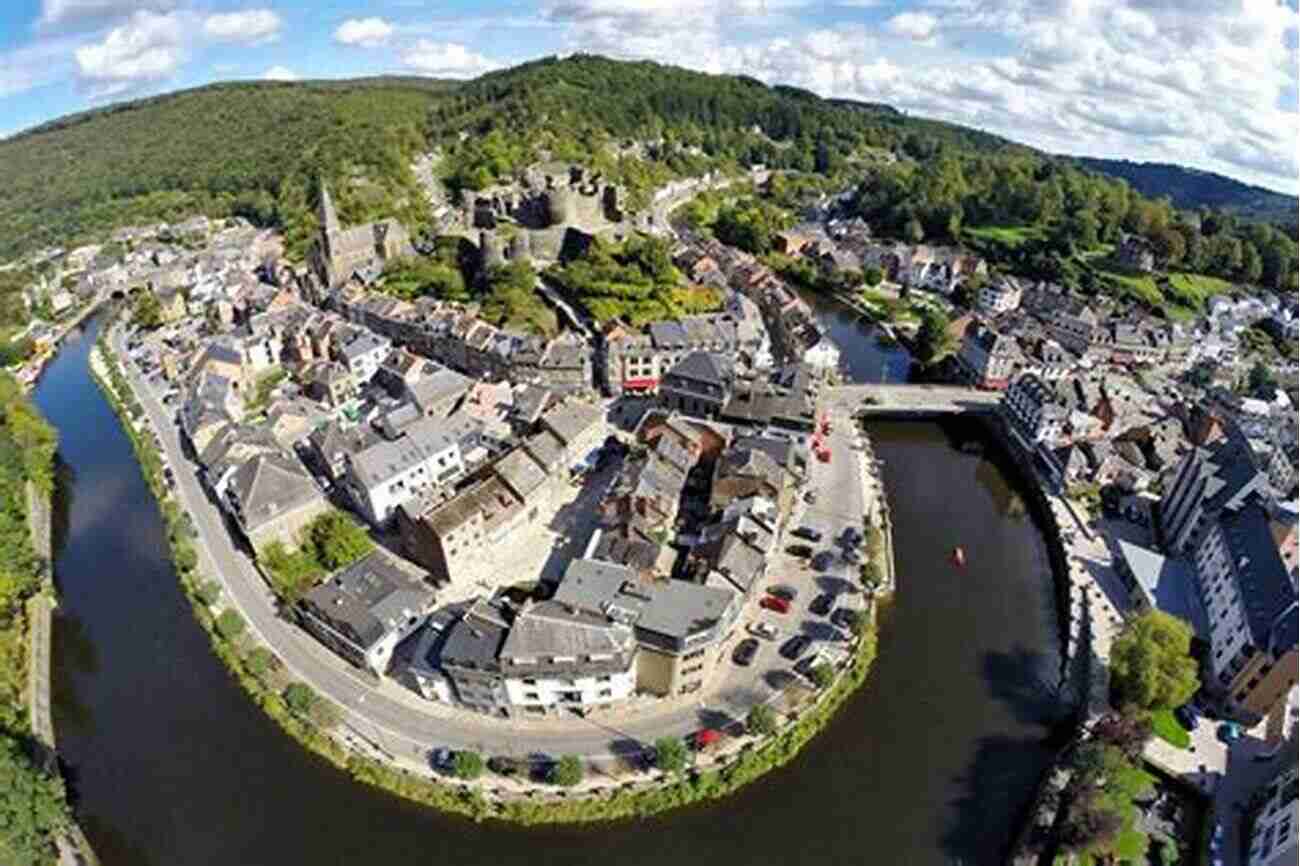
[35,310,1060,866]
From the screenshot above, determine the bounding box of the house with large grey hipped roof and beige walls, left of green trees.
[222,454,330,550]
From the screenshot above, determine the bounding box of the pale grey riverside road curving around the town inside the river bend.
[112,322,862,768]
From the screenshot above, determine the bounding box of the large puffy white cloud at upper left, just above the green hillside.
[74,12,185,98]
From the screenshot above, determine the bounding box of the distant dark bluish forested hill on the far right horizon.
[1074,156,1300,225]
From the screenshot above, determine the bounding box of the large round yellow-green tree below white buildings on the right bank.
[1110,610,1200,711]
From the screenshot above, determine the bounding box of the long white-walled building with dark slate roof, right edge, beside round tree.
[1195,502,1300,726]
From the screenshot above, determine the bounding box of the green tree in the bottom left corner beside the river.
[0,733,69,866]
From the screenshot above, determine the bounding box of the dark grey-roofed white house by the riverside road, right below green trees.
[298,550,433,676]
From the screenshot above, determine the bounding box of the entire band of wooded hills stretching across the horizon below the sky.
[0,55,1296,300]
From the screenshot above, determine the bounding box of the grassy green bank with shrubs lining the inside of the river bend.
[90,308,894,824]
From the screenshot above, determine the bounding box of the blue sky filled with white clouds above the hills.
[0,0,1300,194]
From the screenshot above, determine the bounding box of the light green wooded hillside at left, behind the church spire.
[0,79,457,260]
